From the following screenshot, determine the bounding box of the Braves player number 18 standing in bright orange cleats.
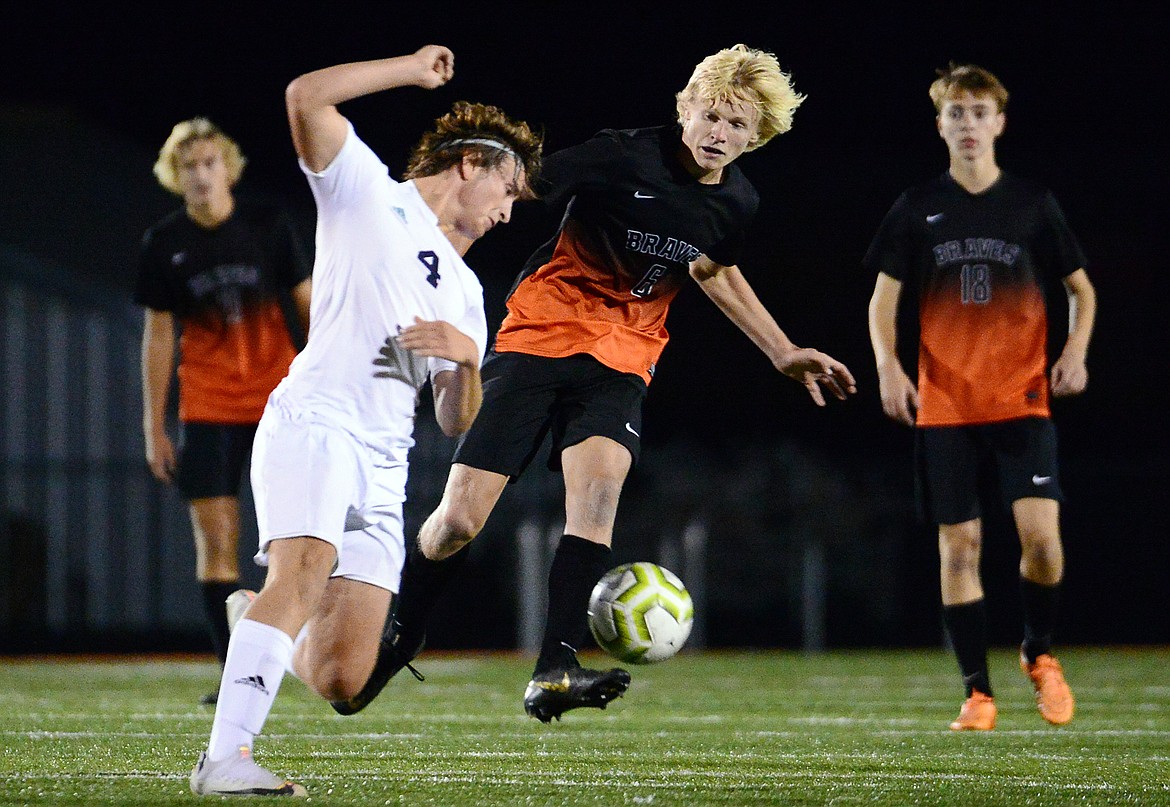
[866,63,1096,731]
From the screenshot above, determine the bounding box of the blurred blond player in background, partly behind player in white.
[135,118,311,704]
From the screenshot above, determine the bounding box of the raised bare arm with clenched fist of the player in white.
[284,44,455,171]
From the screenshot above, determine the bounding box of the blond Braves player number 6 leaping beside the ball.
[333,46,855,722]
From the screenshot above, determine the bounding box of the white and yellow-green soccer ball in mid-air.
[589,560,695,664]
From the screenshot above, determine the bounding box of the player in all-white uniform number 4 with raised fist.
[191,46,541,795]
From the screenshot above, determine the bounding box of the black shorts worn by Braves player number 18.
[915,418,1064,524]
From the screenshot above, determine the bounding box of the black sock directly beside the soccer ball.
[532,534,612,676]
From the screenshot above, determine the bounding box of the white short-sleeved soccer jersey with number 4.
[271,124,488,462]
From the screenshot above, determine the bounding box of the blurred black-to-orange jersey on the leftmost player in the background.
[135,201,311,423]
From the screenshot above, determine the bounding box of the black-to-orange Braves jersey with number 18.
[865,173,1086,426]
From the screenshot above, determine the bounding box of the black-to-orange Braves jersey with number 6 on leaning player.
[495,126,759,382]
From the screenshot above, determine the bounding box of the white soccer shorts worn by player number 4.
[252,405,406,593]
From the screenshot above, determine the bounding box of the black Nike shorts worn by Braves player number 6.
[452,352,646,481]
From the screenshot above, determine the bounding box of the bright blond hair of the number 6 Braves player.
[675,44,805,151]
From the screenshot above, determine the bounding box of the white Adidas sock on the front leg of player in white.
[207,619,293,761]
